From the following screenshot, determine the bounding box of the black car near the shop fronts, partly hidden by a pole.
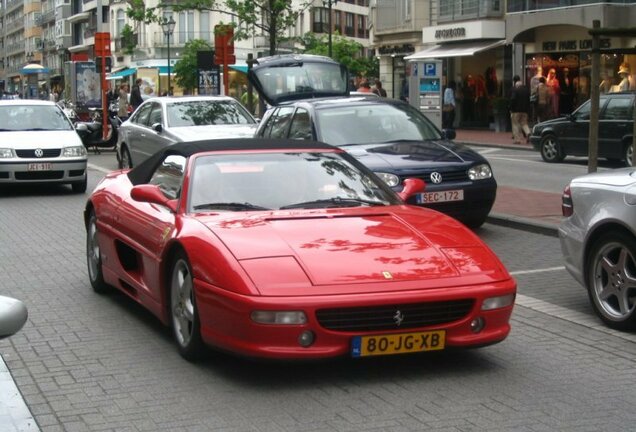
[530,92,636,166]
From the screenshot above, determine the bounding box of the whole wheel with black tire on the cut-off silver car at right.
[585,231,636,330]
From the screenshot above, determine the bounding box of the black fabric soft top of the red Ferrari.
[128,138,338,185]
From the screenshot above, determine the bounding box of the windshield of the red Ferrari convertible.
[188,152,399,211]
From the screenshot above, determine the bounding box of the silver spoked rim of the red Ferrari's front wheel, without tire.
[170,259,194,348]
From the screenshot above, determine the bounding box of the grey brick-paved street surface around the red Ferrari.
[0,153,636,432]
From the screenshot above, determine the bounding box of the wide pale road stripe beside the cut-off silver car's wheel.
[515,293,636,342]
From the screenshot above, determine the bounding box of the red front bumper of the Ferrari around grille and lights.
[195,279,516,359]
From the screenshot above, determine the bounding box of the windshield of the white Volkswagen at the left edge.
[0,105,73,131]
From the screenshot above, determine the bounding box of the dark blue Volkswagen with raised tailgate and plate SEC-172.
[248,54,497,227]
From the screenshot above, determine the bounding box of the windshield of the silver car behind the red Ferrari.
[167,100,255,127]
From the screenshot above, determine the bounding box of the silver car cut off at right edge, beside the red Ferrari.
[559,168,636,330]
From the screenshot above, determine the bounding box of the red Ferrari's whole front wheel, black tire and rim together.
[169,252,204,361]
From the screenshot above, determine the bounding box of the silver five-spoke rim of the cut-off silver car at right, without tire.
[590,241,636,321]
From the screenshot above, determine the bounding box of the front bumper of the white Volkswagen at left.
[0,158,87,184]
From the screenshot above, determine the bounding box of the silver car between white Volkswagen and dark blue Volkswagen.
[117,96,258,168]
